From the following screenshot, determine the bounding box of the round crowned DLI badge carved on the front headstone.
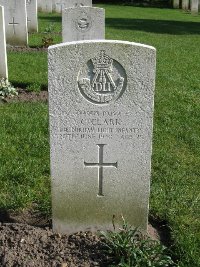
[78,50,127,104]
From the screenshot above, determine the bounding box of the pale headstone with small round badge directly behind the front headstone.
[62,7,105,42]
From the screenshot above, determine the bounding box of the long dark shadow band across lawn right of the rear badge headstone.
[106,18,200,35]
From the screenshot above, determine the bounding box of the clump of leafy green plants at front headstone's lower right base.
[100,216,176,267]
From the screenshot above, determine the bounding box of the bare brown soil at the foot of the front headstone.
[0,209,163,267]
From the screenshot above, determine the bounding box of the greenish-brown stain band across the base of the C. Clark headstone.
[53,193,147,230]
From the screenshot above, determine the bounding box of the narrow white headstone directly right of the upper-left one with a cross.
[26,0,38,32]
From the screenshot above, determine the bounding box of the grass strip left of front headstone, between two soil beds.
[0,103,50,214]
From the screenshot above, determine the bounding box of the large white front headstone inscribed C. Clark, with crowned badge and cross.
[49,40,156,233]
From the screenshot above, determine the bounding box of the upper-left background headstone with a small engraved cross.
[0,0,28,46]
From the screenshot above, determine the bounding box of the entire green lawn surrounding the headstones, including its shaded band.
[0,5,200,267]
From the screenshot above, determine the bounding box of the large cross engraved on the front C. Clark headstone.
[84,144,117,196]
